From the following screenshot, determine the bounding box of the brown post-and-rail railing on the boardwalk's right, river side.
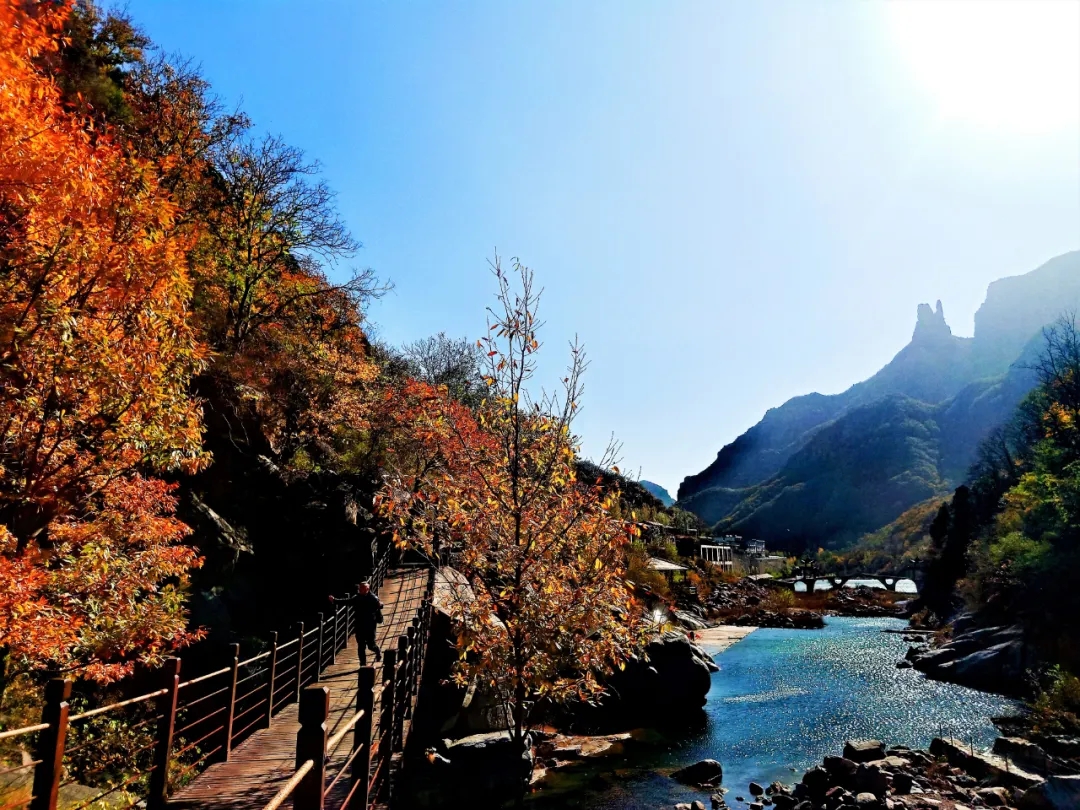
[264,568,435,810]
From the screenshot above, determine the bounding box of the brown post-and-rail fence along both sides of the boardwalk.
[0,549,434,810]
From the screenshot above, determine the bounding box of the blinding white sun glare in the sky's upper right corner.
[885,0,1080,134]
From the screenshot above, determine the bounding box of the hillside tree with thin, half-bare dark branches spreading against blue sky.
[193,131,387,463]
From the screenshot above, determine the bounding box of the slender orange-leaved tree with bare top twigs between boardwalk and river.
[380,259,642,744]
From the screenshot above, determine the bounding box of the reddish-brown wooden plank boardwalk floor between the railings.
[168,569,428,810]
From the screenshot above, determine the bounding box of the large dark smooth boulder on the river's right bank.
[908,626,1032,694]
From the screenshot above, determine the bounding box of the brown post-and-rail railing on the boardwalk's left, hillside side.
[0,548,401,810]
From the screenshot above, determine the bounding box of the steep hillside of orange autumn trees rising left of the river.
[0,0,643,721]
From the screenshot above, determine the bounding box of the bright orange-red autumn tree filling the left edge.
[0,0,205,689]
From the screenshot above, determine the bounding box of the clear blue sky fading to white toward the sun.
[127,0,1080,492]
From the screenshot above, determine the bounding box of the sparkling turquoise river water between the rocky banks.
[530,618,1015,810]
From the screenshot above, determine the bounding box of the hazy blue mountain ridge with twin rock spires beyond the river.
[678,251,1080,552]
